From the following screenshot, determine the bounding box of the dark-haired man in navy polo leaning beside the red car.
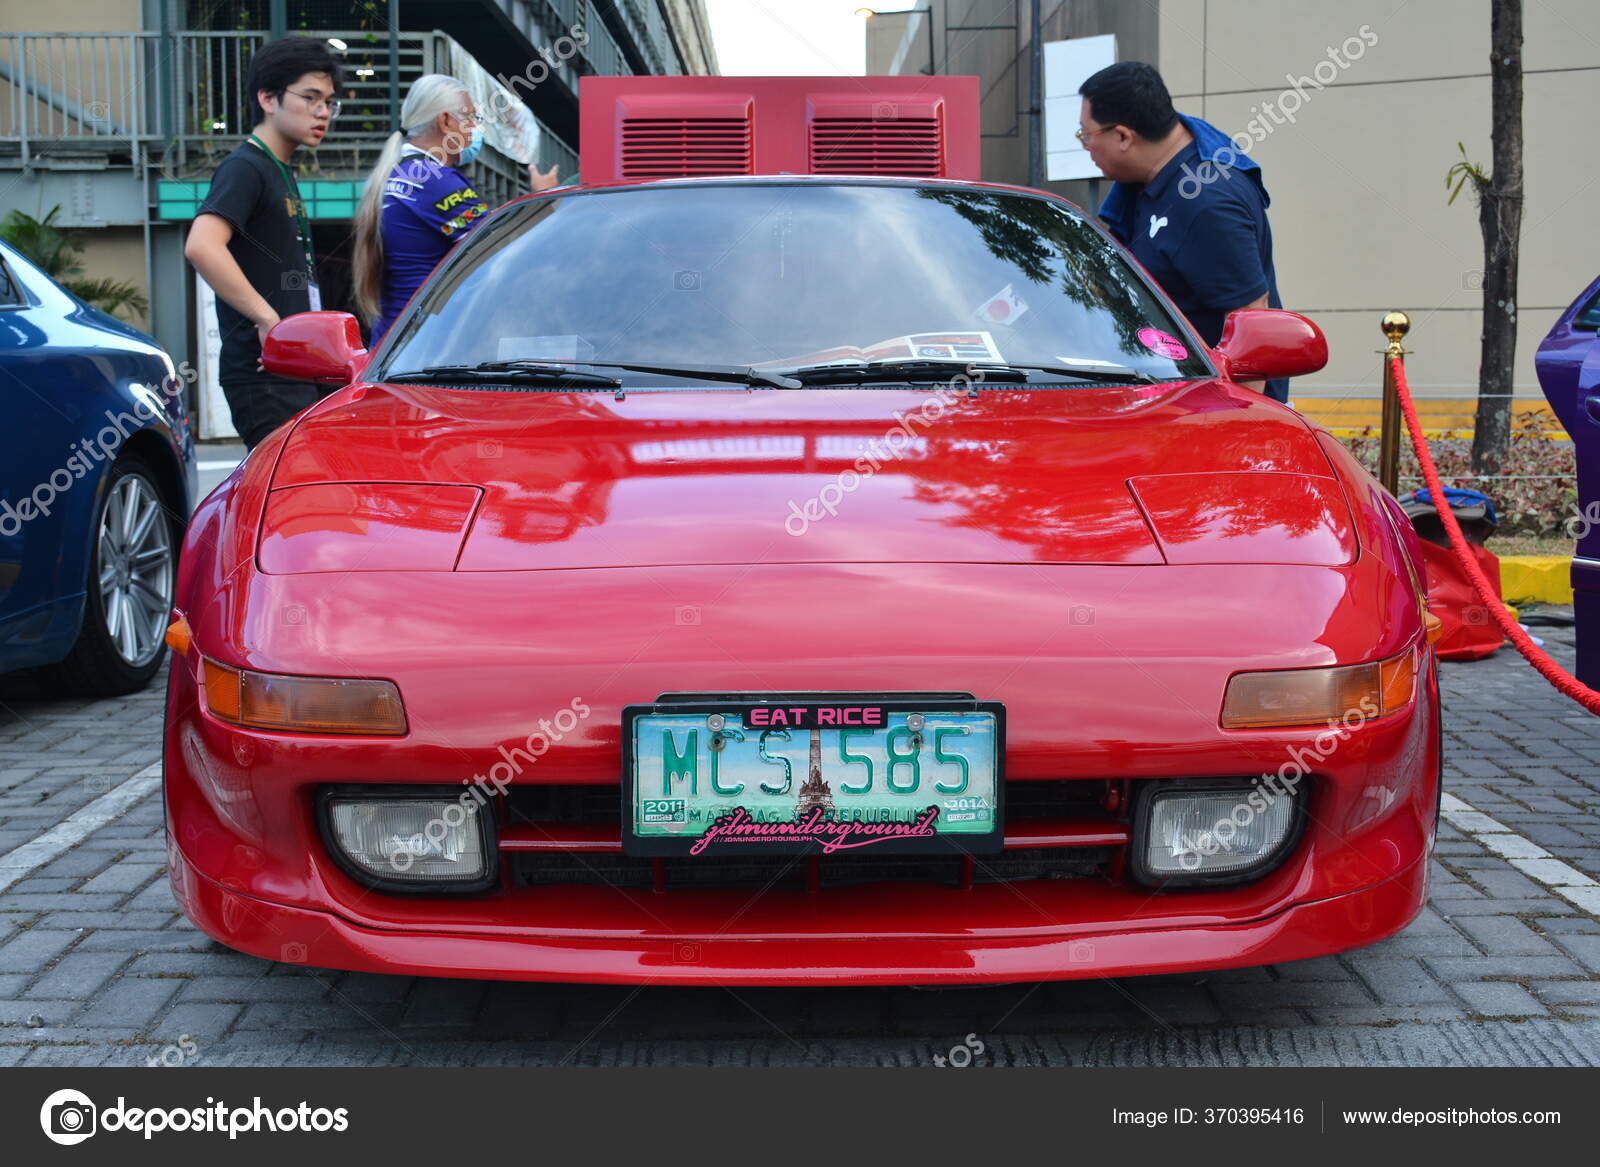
[1077,61,1290,402]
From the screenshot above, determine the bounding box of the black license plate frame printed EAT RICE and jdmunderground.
[619,692,1005,858]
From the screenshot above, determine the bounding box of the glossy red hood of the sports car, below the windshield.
[261,381,1355,571]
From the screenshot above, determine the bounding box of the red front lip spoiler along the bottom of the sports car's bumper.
[170,845,1427,986]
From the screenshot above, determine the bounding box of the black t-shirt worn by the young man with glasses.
[197,141,310,383]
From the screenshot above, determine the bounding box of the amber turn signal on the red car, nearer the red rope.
[1222,648,1416,730]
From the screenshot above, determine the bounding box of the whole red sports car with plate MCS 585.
[165,176,1440,985]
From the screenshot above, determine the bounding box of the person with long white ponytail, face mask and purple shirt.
[355,74,557,346]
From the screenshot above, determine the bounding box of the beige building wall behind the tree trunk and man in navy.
[867,0,1600,399]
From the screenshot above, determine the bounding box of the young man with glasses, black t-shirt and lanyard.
[184,37,342,450]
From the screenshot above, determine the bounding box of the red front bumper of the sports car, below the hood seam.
[165,560,1438,985]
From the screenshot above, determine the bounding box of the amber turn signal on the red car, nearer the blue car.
[202,658,406,736]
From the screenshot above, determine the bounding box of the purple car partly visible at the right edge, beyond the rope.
[1533,280,1600,687]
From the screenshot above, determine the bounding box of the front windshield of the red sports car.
[378,182,1210,383]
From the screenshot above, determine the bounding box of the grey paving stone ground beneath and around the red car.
[0,617,1600,1066]
